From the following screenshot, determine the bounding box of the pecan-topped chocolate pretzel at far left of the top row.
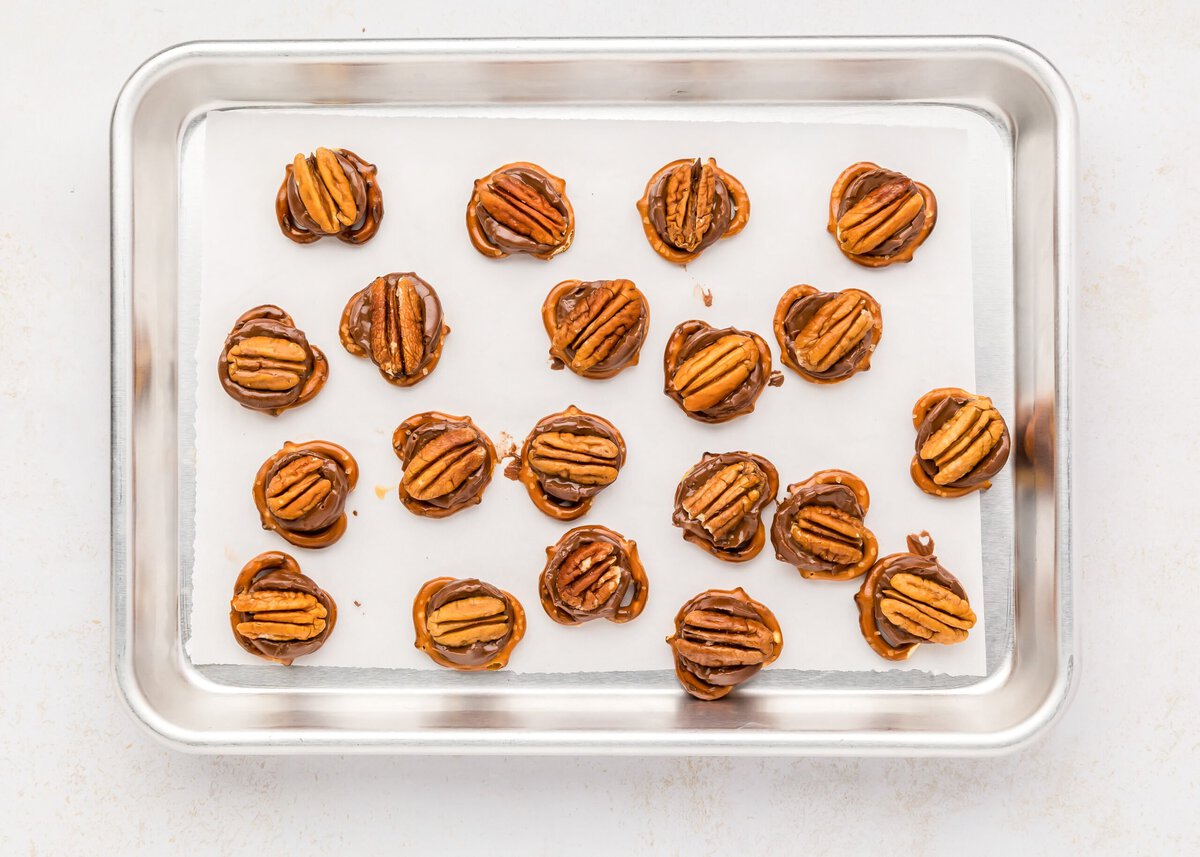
[275,149,383,244]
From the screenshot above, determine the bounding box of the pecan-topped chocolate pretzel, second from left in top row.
[467,161,575,259]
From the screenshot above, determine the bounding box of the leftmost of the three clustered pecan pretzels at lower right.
[671,453,779,563]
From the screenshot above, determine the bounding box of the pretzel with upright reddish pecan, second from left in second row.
[338,272,450,386]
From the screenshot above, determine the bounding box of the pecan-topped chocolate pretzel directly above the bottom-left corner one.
[253,441,359,547]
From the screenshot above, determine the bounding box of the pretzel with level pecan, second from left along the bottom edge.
[413,577,526,672]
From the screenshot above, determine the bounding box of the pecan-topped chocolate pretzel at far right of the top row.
[829,161,937,268]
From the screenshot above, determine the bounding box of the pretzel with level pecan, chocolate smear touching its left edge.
[509,404,625,521]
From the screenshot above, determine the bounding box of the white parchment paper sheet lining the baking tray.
[187,110,985,676]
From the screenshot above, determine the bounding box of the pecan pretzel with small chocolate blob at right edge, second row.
[662,320,782,422]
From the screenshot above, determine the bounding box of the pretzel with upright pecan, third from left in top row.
[637,157,750,265]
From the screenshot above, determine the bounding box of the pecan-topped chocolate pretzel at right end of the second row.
[774,286,883,384]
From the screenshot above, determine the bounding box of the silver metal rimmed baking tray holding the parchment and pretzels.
[112,37,1078,755]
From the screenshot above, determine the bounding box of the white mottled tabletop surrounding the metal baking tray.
[0,0,1200,855]
